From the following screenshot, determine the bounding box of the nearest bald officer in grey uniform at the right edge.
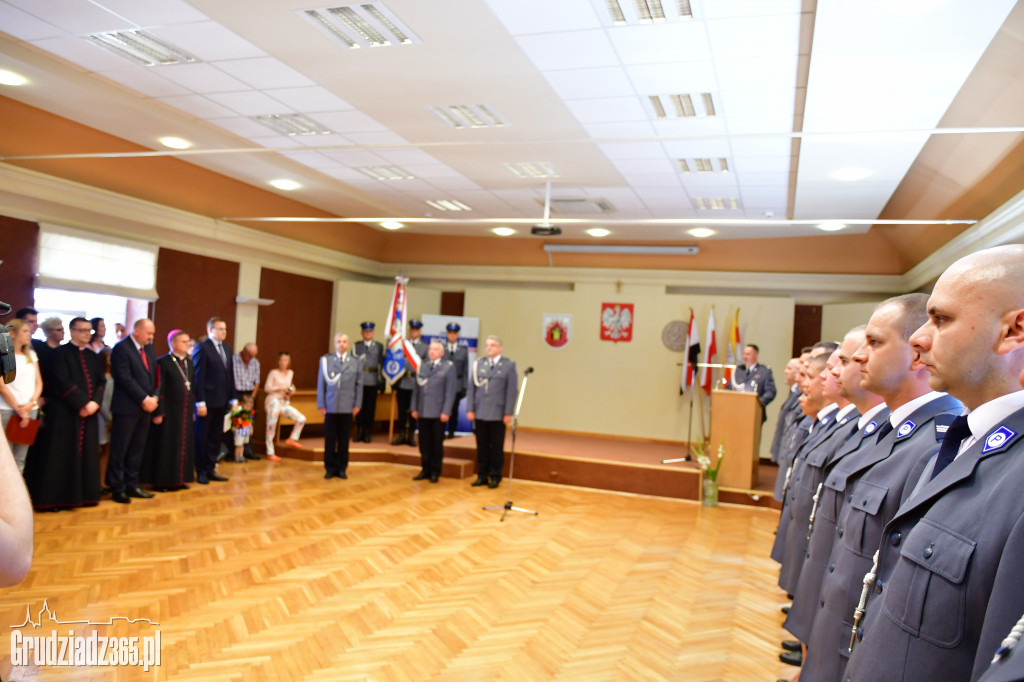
[847,244,1024,681]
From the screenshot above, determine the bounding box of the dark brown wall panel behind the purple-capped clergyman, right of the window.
[152,248,239,355]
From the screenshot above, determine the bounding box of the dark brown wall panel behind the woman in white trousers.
[256,267,331,388]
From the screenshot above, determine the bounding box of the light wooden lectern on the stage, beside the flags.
[708,390,762,491]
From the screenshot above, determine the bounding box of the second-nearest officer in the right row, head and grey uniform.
[791,294,963,682]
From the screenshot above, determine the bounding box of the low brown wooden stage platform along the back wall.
[268,428,780,509]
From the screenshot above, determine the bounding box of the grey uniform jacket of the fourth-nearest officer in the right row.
[778,409,860,593]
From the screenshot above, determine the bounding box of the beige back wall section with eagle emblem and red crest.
[462,283,794,454]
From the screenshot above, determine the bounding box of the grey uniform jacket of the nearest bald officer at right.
[849,403,1024,682]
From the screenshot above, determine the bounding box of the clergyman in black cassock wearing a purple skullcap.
[142,330,196,493]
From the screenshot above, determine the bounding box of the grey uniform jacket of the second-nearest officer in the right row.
[801,394,964,682]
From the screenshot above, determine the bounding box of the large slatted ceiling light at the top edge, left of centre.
[296,2,423,49]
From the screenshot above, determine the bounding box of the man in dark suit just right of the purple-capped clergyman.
[193,317,234,485]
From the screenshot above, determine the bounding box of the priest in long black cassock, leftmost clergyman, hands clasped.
[25,317,105,511]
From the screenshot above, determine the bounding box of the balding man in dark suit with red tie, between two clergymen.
[106,317,158,504]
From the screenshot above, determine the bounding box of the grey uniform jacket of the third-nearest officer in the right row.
[782,408,890,642]
